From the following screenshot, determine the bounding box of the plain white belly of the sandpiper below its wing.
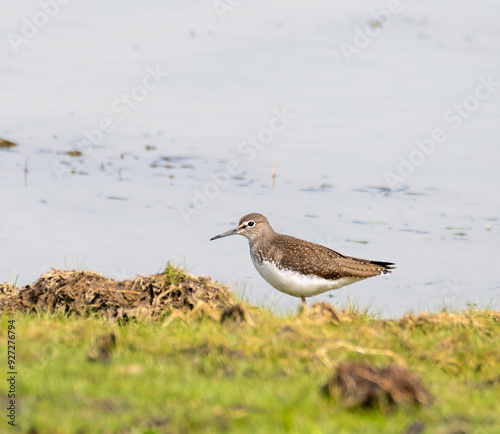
[250,255,362,297]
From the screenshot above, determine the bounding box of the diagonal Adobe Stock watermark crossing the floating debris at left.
[52,65,168,182]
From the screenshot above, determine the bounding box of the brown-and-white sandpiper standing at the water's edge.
[210,213,394,306]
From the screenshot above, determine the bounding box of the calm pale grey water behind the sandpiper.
[0,1,500,317]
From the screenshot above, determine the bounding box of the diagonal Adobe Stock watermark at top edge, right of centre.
[339,0,403,63]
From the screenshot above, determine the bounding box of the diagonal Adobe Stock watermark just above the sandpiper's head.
[179,106,295,223]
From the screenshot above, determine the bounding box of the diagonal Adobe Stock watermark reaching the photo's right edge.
[384,74,500,190]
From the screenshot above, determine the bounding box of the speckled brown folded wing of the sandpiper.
[264,234,393,280]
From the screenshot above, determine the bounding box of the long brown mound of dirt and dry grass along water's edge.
[0,265,234,319]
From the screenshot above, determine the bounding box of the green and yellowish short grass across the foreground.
[1,306,500,434]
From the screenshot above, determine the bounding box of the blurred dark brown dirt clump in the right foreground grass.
[322,363,432,409]
